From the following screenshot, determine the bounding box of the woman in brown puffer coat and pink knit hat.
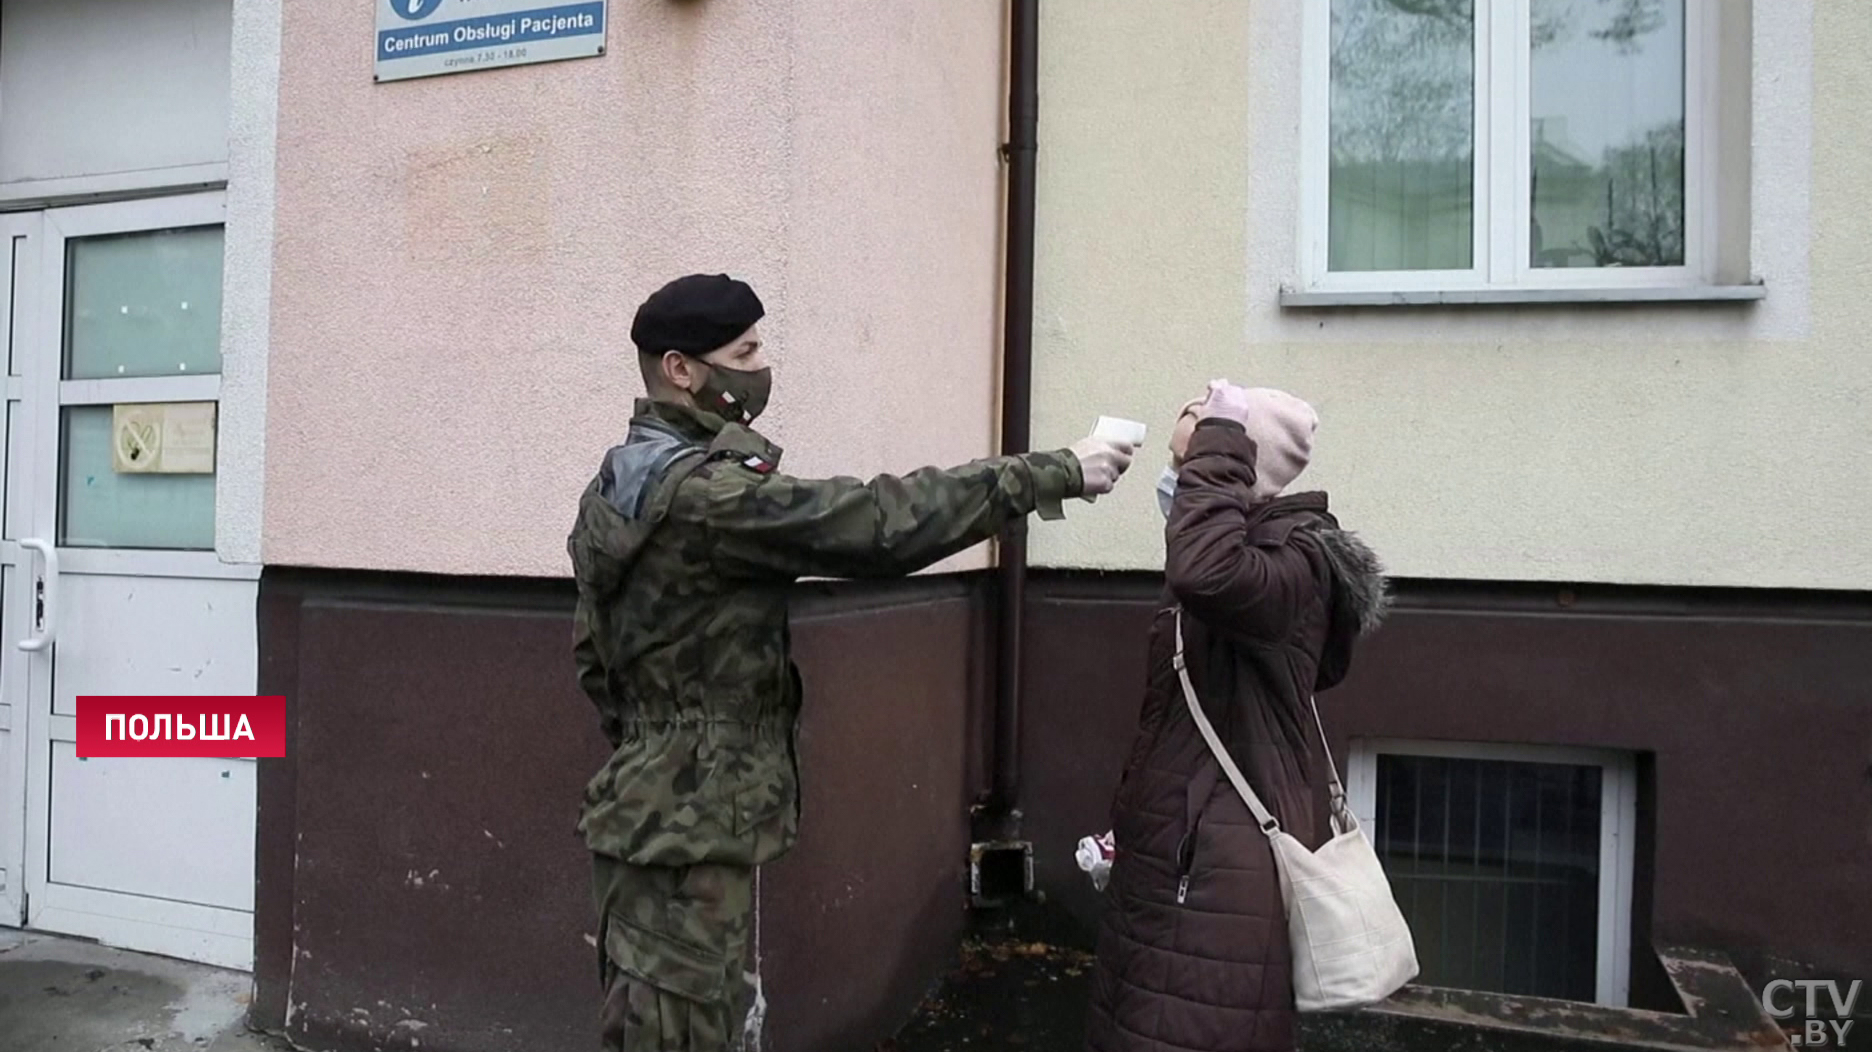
[1086,382,1385,1052]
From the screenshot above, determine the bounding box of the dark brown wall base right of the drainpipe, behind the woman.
[1022,575,1872,986]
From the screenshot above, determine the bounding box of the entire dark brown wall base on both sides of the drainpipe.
[253,571,1872,1052]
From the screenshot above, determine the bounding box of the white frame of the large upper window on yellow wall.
[1299,0,1720,298]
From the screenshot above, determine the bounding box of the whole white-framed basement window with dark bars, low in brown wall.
[1346,739,1638,1007]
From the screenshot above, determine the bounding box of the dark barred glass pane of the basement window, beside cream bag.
[1374,756,1601,1001]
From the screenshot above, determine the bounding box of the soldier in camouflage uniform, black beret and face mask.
[567,275,1131,1052]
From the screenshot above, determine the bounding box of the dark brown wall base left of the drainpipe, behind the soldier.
[253,571,985,1052]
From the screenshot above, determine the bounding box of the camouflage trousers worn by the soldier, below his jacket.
[592,854,758,1052]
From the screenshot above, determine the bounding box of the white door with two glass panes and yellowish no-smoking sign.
[0,193,258,970]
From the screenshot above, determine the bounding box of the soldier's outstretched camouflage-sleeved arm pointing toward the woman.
[695,449,1086,578]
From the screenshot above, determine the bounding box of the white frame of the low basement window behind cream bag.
[1346,738,1638,1007]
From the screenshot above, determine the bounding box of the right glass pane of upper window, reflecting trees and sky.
[1531,0,1685,268]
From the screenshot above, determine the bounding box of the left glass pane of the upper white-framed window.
[1327,0,1475,271]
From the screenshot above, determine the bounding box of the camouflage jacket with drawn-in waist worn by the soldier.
[567,401,1084,867]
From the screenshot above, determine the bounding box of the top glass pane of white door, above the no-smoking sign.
[66,226,221,380]
